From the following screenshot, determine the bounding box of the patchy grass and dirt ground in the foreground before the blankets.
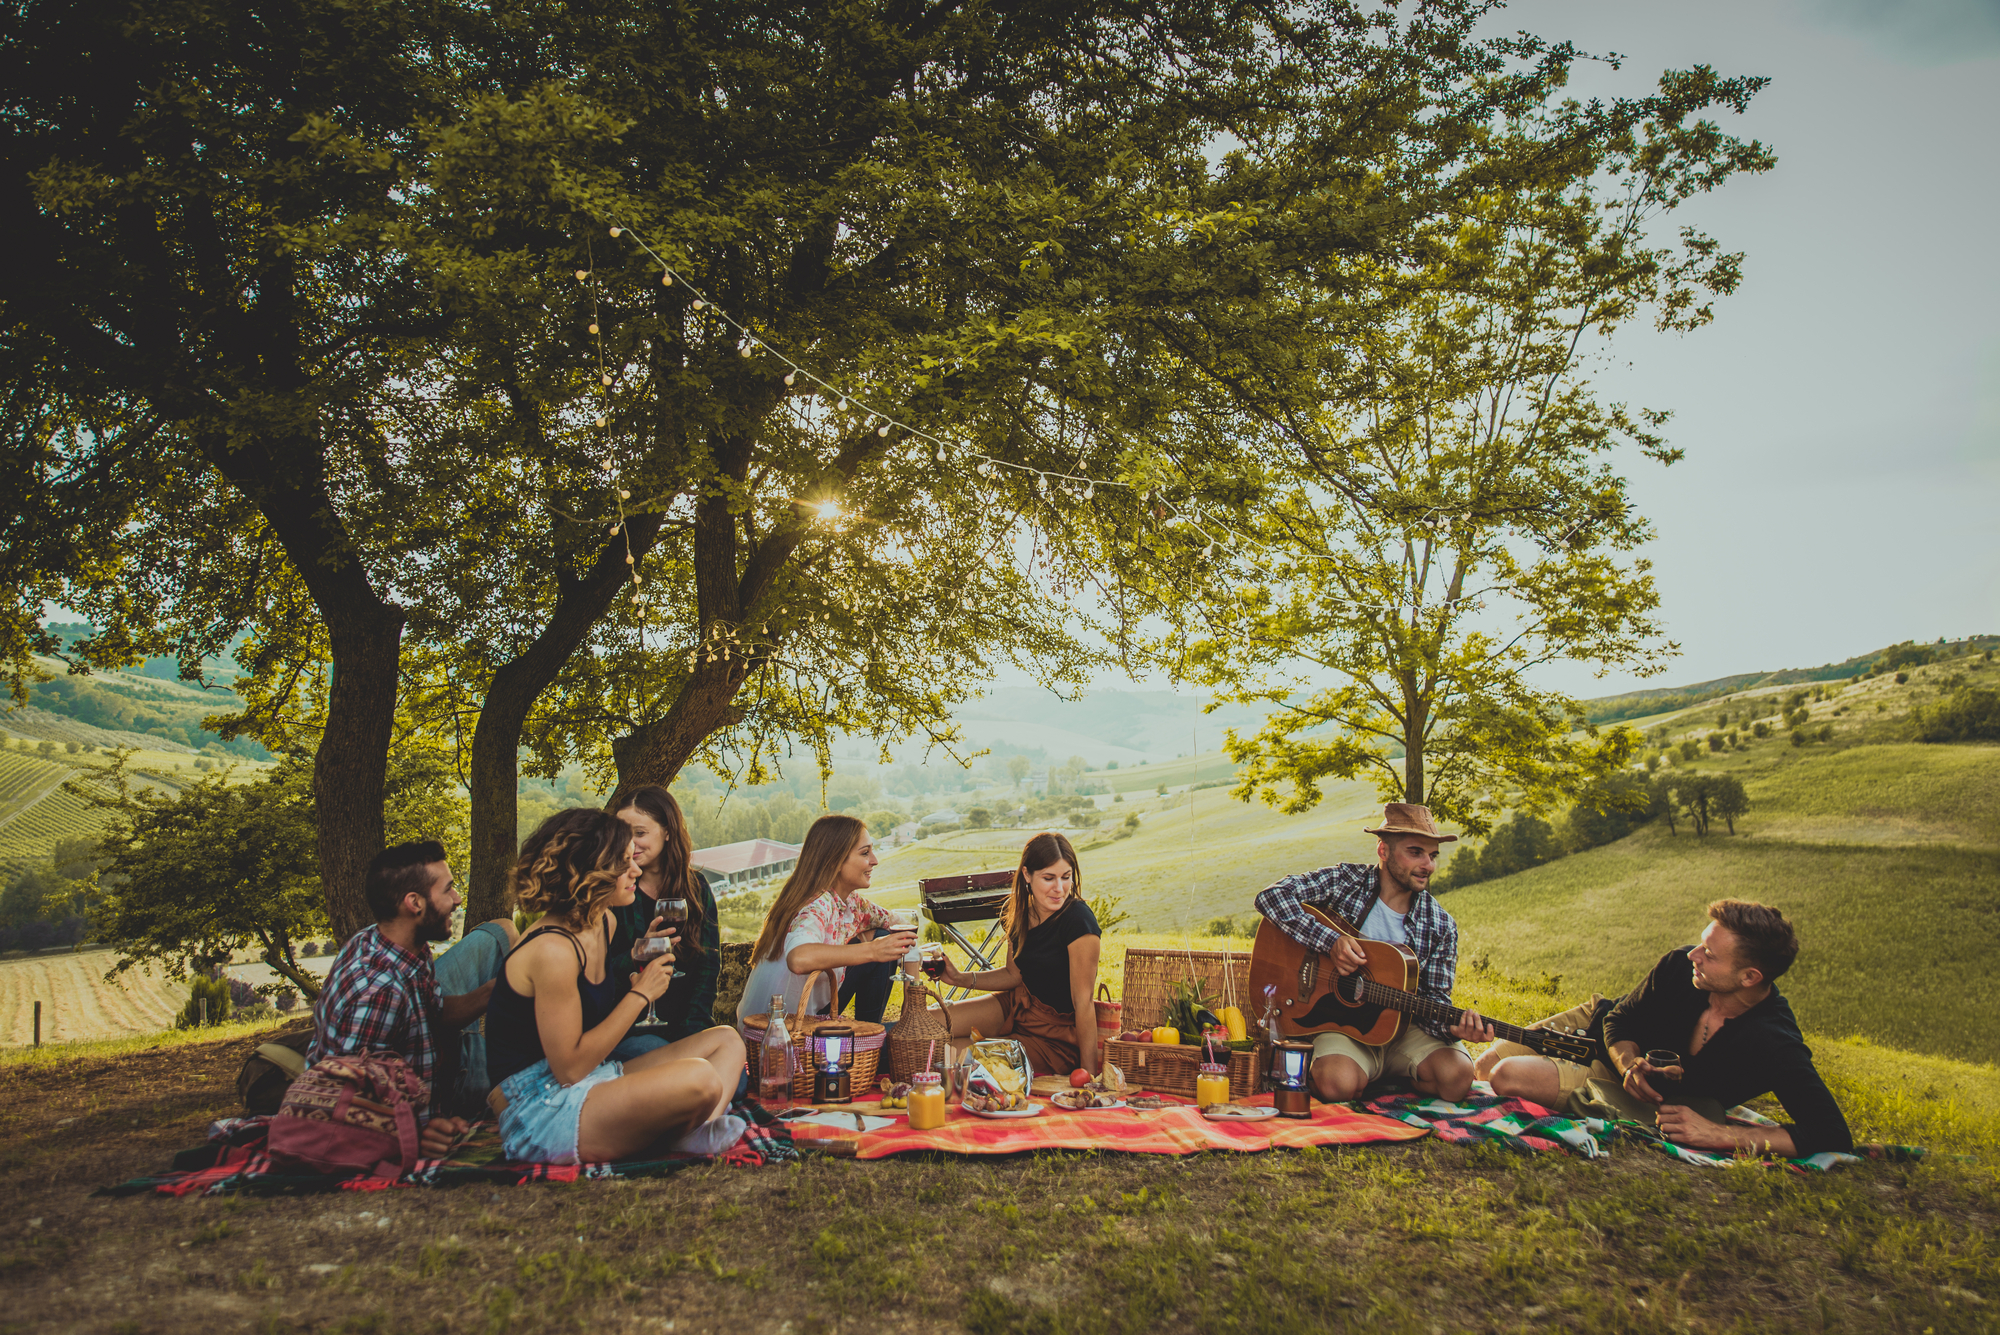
[0,1039,2000,1335]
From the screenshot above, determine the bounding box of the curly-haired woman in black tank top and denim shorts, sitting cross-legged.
[486,807,744,1163]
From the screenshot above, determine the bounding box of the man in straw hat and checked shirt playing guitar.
[1256,801,1494,1103]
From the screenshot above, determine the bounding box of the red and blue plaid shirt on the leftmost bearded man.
[306,927,448,1117]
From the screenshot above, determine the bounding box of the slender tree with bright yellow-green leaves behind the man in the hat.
[1184,80,1770,833]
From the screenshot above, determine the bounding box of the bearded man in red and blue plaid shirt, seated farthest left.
[306,839,516,1155]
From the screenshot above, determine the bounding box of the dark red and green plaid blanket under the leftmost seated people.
[98,1099,800,1195]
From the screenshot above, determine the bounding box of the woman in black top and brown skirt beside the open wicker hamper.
[944,833,1104,1075]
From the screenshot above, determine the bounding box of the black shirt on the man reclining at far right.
[1604,945,1854,1155]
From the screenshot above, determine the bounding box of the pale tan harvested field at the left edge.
[0,949,188,1047]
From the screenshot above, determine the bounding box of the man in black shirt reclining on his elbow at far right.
[1478,899,1854,1159]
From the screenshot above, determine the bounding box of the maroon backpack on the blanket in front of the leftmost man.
[266,1053,430,1177]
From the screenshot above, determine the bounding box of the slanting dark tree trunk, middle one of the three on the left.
[466,514,660,923]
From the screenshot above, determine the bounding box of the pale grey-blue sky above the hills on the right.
[1040,0,2000,695]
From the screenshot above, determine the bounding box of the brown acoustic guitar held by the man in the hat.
[1250,903,1598,1065]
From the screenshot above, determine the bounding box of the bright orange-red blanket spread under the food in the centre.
[854,1093,1424,1159]
